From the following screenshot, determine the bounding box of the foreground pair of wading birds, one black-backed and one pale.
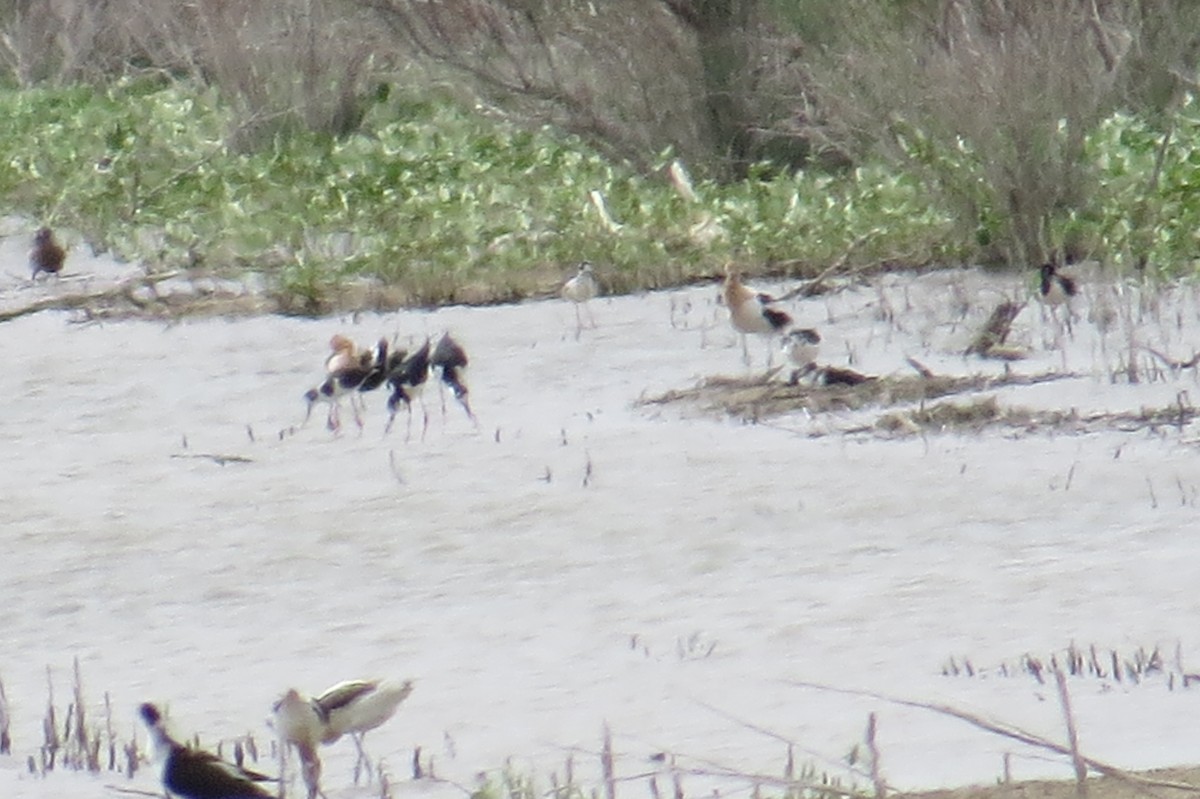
[138,680,413,799]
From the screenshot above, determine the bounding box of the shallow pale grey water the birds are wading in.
[0,256,1200,799]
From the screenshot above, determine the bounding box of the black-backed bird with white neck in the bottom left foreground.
[138,702,274,799]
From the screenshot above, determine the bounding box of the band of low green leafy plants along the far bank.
[0,79,1200,311]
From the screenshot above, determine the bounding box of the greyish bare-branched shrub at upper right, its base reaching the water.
[814,0,1196,264]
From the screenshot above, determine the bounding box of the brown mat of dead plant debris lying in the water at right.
[643,364,1198,437]
